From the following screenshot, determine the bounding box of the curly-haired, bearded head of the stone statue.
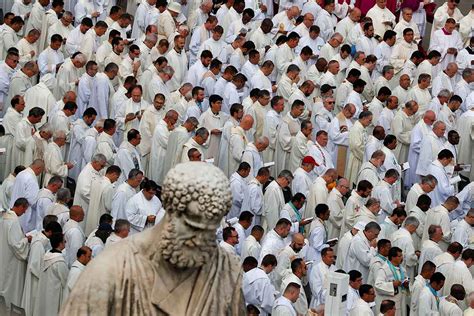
[160,162,232,268]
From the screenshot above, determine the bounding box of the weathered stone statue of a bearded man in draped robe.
[61,162,246,316]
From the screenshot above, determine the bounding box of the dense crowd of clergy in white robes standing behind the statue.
[0,0,474,316]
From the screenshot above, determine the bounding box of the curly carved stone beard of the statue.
[160,222,217,268]
